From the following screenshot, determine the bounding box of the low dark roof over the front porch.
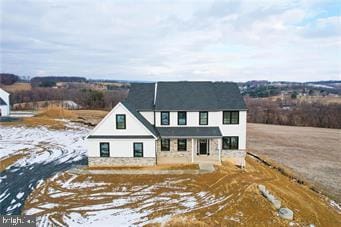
[157,127,222,138]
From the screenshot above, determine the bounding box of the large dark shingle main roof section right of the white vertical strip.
[155,82,246,111]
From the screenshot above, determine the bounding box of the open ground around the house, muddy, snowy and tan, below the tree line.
[0,102,341,226]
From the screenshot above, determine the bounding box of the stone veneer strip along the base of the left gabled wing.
[88,157,156,167]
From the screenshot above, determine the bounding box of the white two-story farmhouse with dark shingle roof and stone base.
[86,82,247,166]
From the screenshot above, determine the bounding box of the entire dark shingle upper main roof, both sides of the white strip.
[126,81,247,111]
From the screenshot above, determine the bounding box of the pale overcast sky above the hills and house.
[0,0,341,81]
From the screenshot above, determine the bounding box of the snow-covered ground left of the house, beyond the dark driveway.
[0,123,89,168]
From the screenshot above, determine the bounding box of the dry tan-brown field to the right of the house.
[247,123,341,203]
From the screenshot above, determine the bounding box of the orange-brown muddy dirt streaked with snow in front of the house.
[24,158,341,226]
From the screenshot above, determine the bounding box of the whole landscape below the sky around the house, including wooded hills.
[0,75,341,226]
